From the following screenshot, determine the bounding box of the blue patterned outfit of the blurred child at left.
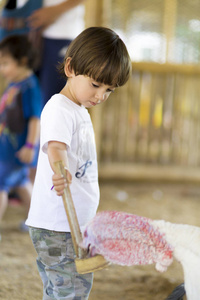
[0,75,41,192]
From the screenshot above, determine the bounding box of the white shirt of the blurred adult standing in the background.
[43,0,85,39]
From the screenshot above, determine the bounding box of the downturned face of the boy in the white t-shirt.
[66,75,115,108]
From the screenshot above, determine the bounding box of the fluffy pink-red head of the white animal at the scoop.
[80,211,173,272]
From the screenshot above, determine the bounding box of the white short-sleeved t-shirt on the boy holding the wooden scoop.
[26,94,99,232]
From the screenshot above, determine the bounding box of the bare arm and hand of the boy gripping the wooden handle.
[47,141,72,196]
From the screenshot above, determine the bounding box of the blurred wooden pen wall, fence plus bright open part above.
[85,0,200,181]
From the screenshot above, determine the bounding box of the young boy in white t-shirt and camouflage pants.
[26,27,131,300]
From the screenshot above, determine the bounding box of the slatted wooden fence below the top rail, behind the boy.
[91,63,200,181]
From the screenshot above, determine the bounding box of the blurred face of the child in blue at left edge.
[0,52,24,82]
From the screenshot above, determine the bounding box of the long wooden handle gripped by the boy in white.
[54,161,87,258]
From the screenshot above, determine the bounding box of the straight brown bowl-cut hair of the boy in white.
[59,27,131,87]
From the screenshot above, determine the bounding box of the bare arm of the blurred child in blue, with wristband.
[16,117,40,163]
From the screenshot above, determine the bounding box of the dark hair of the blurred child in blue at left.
[0,35,37,69]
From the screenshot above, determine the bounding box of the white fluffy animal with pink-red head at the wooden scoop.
[81,211,200,300]
